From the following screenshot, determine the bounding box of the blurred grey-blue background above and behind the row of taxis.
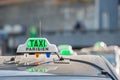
[0,0,120,55]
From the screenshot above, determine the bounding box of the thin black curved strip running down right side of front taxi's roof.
[64,58,118,80]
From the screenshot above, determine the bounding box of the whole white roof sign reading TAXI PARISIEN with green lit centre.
[17,38,58,53]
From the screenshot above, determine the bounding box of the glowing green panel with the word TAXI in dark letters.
[27,38,48,48]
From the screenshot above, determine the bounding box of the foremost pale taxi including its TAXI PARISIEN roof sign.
[0,38,120,80]
